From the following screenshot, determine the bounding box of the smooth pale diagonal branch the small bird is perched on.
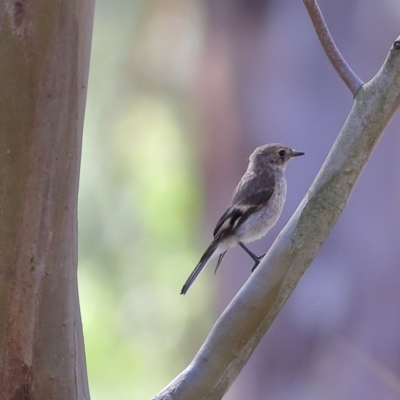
[154,36,400,400]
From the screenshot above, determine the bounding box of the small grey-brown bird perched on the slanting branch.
[181,143,304,294]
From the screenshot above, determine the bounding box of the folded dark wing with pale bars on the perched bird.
[214,171,275,238]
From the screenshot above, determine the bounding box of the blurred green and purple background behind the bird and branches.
[79,0,400,400]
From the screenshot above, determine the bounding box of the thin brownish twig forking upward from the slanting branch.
[303,0,364,96]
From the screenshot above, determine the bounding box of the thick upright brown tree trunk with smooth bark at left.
[0,0,94,400]
